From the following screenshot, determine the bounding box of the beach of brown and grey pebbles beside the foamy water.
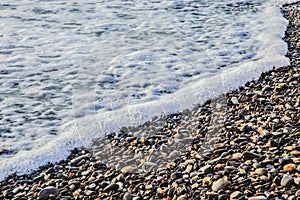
[0,3,300,200]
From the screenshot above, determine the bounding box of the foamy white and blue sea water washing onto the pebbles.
[0,0,295,180]
